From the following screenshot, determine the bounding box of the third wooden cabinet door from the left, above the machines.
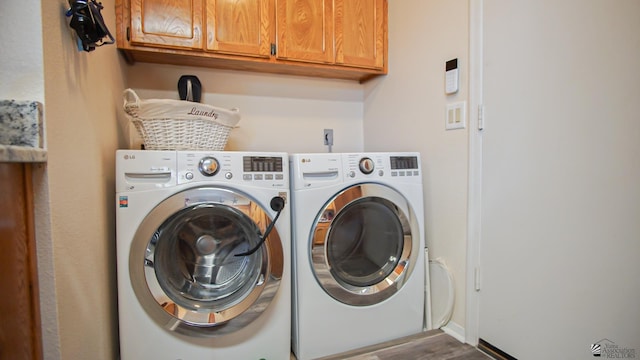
[276,0,336,63]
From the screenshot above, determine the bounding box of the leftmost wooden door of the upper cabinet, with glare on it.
[131,0,203,49]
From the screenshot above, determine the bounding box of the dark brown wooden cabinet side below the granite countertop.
[0,162,43,360]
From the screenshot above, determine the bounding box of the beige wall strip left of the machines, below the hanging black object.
[41,0,124,359]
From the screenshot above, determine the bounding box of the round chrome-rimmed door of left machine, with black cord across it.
[130,188,283,336]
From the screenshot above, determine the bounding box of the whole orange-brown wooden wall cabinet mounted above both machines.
[116,0,387,82]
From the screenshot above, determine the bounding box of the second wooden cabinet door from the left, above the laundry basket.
[206,0,275,57]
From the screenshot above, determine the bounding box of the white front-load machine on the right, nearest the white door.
[290,153,426,360]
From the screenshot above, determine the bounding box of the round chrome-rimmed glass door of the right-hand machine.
[311,184,420,305]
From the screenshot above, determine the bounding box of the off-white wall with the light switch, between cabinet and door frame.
[364,0,469,336]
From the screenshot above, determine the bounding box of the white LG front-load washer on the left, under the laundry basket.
[116,150,291,360]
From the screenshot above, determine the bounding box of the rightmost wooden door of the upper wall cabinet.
[334,0,387,69]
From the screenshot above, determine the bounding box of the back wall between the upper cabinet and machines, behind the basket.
[124,63,363,153]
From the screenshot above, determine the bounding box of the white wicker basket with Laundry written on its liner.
[122,89,240,150]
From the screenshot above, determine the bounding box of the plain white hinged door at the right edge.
[479,0,640,359]
